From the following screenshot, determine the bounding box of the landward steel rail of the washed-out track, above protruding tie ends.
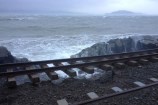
[0,54,158,77]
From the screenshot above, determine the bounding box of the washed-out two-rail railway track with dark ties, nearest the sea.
[0,49,158,87]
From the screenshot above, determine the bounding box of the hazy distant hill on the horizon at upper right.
[105,10,143,16]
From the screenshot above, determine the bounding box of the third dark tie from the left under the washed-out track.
[41,64,59,80]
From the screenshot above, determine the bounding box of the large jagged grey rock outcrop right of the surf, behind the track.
[71,36,158,58]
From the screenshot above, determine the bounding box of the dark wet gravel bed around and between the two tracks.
[0,63,158,105]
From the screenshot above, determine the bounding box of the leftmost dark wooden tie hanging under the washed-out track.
[7,69,17,88]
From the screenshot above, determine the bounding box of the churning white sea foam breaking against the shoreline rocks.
[0,34,152,61]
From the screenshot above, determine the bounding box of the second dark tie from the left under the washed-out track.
[25,66,40,84]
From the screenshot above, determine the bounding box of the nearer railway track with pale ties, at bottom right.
[66,78,158,105]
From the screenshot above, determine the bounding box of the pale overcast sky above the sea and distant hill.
[0,0,158,15]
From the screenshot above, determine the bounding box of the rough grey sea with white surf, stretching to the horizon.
[0,15,158,61]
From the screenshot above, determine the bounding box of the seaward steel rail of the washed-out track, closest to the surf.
[0,48,158,68]
